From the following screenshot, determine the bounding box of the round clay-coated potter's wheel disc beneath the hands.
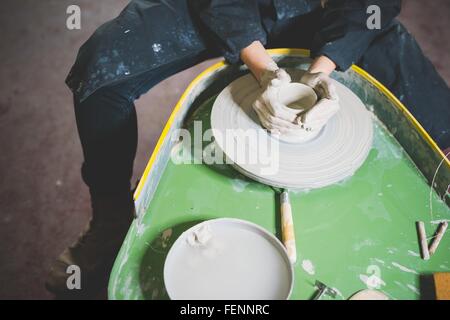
[211,74,373,189]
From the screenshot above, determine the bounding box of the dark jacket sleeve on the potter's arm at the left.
[190,0,267,63]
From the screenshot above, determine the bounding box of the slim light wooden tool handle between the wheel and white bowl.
[280,190,297,264]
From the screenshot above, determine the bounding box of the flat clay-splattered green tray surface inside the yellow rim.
[109,95,450,299]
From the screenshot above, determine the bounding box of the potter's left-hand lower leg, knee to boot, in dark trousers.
[46,80,137,298]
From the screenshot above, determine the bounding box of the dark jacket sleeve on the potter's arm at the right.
[312,0,401,70]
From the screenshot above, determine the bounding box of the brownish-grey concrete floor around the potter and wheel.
[0,0,450,299]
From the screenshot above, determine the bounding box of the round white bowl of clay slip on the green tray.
[164,218,294,300]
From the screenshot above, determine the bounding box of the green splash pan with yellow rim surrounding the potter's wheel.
[108,49,450,300]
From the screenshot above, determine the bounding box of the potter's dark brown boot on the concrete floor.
[45,192,134,299]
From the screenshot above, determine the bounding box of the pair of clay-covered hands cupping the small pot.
[241,41,339,133]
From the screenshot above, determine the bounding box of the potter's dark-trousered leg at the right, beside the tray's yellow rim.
[357,21,450,149]
